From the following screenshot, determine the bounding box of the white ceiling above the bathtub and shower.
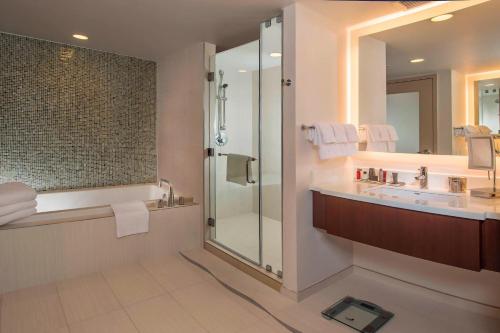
[0,0,294,60]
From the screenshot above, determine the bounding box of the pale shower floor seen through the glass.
[216,213,282,273]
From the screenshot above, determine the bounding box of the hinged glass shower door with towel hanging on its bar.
[209,41,261,265]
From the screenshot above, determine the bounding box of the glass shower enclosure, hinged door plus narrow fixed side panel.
[206,17,282,276]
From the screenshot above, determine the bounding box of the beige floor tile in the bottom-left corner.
[0,284,66,333]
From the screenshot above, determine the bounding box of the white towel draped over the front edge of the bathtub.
[111,200,149,238]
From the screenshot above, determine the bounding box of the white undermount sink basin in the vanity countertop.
[365,186,460,204]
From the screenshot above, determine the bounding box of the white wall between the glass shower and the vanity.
[283,3,352,292]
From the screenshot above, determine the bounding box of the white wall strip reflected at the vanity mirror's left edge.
[359,36,387,125]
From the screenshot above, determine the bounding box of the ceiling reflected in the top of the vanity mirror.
[372,0,500,77]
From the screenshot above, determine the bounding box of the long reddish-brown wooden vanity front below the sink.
[313,192,482,271]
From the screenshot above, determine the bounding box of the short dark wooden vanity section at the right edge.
[481,220,500,272]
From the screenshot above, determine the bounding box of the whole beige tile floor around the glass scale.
[0,249,500,333]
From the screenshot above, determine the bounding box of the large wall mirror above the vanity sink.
[358,1,500,155]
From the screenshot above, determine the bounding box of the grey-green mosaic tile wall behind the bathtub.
[0,33,156,191]
